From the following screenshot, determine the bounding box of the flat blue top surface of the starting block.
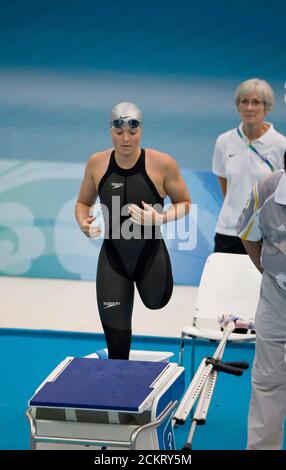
[29,358,168,412]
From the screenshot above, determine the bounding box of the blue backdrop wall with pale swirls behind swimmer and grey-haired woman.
[0,0,286,284]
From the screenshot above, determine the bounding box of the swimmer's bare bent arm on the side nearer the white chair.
[163,157,191,224]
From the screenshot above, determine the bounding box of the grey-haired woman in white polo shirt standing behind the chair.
[213,78,286,254]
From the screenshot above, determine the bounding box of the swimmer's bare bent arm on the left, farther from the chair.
[75,157,100,238]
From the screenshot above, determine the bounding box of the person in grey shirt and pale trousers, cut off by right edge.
[237,152,286,450]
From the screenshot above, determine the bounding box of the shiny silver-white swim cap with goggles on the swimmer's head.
[109,102,143,128]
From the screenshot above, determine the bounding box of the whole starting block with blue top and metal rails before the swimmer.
[26,357,185,450]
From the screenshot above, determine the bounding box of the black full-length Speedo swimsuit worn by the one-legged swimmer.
[96,149,173,359]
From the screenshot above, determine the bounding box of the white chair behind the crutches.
[179,253,261,370]
